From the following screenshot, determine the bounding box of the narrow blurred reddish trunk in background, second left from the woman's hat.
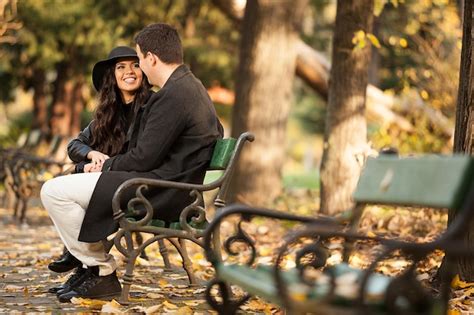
[33,70,48,133]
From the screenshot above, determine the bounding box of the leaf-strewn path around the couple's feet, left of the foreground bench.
[0,207,220,314]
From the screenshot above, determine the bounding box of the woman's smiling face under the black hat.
[114,58,143,103]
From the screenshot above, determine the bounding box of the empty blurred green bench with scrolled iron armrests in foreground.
[205,155,474,314]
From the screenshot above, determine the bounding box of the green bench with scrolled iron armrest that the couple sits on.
[112,132,254,303]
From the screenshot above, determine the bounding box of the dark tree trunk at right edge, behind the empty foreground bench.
[448,0,474,282]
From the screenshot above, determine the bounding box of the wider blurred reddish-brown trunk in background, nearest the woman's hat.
[50,63,74,136]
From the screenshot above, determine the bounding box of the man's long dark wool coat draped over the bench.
[79,65,223,242]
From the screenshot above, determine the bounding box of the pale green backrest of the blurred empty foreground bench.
[353,155,474,209]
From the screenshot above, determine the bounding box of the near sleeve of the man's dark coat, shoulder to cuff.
[102,94,187,172]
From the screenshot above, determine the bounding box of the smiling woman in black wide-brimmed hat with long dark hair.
[48,46,151,293]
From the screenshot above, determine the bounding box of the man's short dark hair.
[135,23,183,64]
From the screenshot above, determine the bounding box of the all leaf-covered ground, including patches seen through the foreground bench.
[0,192,474,314]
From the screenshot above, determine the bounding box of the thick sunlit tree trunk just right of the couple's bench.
[230,0,307,205]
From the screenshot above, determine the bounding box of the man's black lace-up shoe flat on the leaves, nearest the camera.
[59,268,122,302]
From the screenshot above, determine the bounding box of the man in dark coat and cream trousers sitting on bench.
[41,23,222,302]
